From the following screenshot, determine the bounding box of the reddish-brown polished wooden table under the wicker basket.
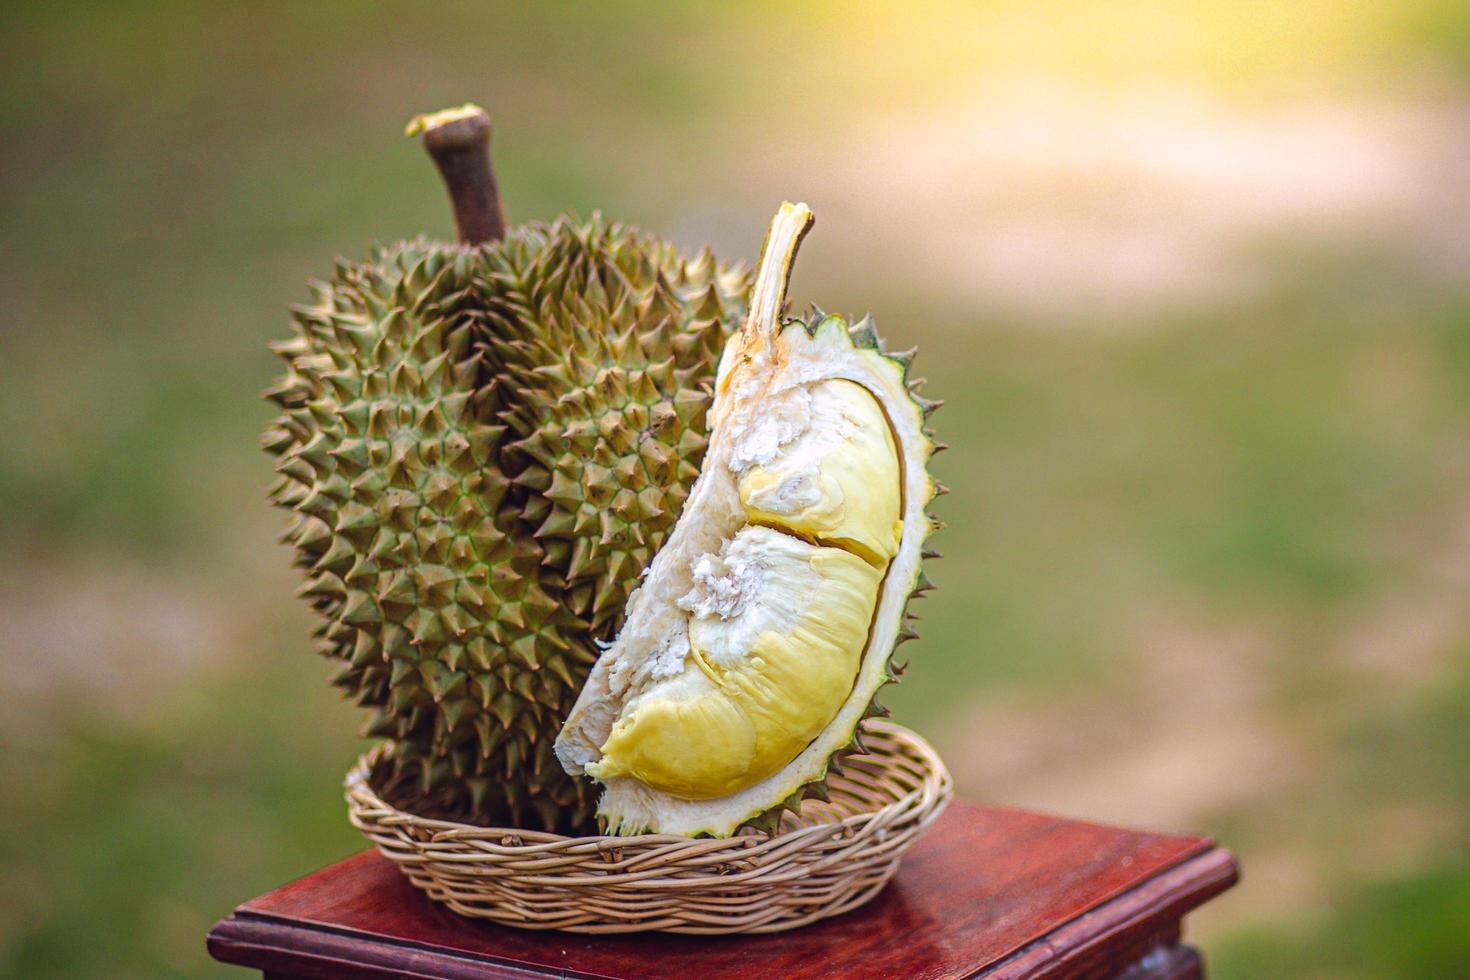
[209,804,1236,980]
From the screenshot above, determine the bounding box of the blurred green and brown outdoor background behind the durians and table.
[0,0,1470,977]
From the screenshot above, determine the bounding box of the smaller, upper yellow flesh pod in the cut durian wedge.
[739,379,903,566]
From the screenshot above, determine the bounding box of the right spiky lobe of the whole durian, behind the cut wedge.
[484,216,750,639]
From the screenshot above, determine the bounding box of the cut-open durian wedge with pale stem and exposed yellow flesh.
[556,204,936,836]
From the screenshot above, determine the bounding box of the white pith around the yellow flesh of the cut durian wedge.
[556,209,933,836]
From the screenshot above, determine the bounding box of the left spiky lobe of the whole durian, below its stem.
[266,241,592,826]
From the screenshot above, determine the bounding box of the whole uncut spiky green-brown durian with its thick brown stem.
[265,106,748,830]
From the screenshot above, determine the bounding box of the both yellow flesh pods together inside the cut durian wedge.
[587,379,903,799]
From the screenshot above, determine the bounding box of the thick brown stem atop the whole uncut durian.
[404,103,506,245]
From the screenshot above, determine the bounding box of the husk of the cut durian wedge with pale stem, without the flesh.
[557,204,944,836]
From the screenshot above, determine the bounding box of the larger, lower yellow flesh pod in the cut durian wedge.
[587,526,882,799]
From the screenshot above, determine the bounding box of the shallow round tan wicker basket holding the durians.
[347,720,954,933]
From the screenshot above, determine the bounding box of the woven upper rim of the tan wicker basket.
[343,718,954,854]
